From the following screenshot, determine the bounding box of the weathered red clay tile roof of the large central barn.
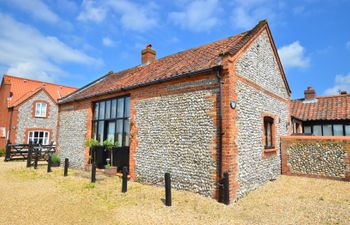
[59,20,290,103]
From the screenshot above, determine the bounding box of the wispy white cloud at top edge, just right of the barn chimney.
[169,0,220,32]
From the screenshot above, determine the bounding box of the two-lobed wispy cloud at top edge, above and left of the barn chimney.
[78,0,158,32]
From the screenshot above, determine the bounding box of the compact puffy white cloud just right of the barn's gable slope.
[278,41,310,68]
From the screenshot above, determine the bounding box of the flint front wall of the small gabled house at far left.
[16,91,58,144]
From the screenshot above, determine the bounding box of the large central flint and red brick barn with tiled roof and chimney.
[58,21,290,200]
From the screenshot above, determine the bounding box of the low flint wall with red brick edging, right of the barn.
[281,136,350,181]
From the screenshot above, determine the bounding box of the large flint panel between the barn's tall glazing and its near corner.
[135,90,217,196]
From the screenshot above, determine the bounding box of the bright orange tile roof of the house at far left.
[2,74,77,107]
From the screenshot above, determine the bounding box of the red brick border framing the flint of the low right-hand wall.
[281,136,350,181]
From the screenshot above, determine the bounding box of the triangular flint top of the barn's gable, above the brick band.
[236,31,289,98]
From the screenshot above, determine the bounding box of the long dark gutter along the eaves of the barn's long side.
[58,66,221,104]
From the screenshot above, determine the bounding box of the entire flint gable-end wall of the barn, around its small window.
[235,31,289,199]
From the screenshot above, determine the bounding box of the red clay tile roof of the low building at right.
[291,94,350,121]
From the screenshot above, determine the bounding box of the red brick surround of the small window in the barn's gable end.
[261,113,278,159]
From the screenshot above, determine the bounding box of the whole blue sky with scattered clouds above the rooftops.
[0,0,350,98]
